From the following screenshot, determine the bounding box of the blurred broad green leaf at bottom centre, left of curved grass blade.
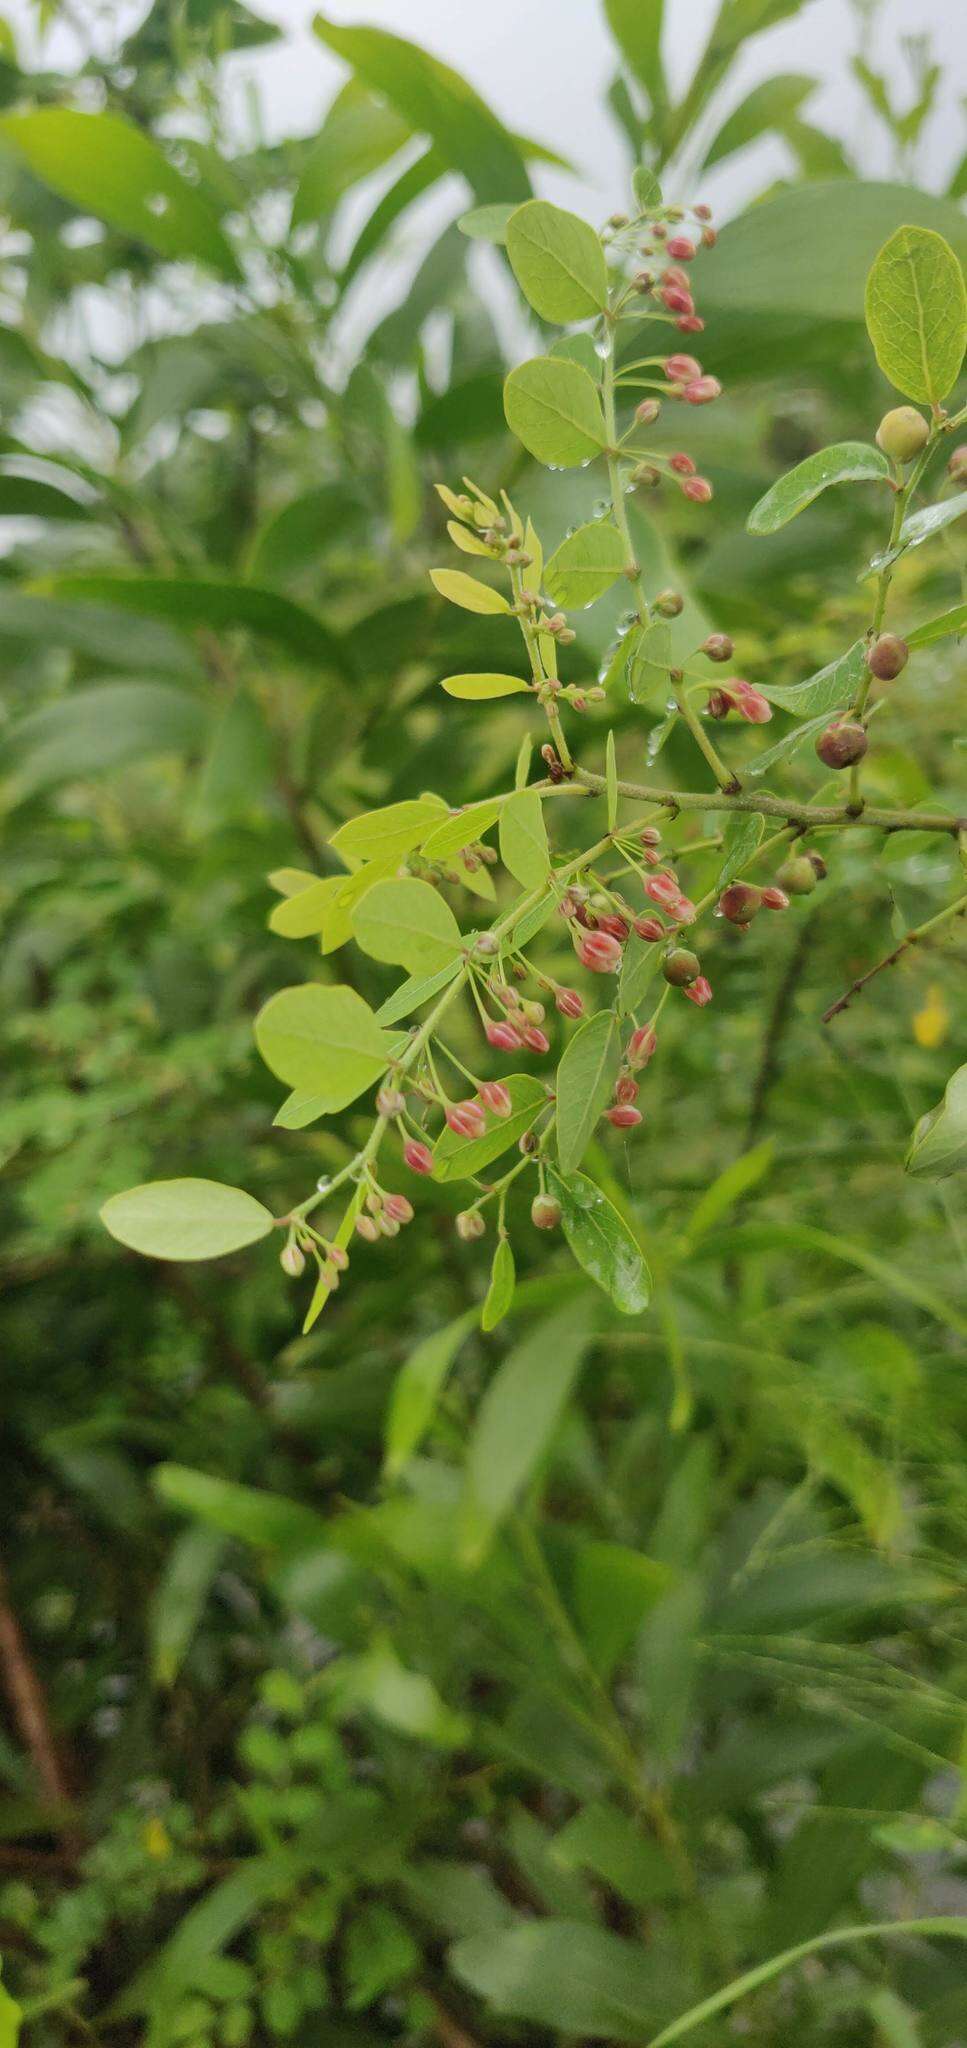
[449,1919,668,2042]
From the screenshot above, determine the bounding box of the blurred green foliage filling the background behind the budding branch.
[0,0,967,2048]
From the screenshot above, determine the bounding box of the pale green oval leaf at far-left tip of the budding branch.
[100,1180,272,1260]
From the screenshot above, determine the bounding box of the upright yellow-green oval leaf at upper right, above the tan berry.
[867,227,967,406]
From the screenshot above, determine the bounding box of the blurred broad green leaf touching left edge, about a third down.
[4,682,209,799]
